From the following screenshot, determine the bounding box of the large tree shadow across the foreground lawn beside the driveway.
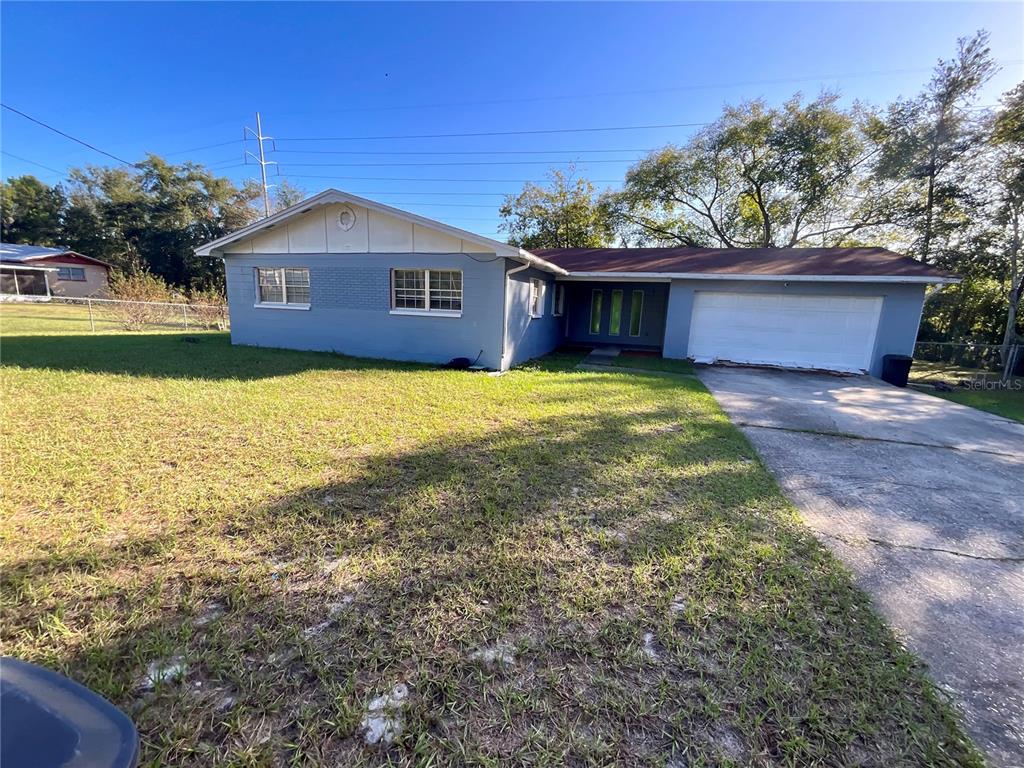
[3,397,969,765]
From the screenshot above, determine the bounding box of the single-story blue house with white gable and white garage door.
[196,189,957,375]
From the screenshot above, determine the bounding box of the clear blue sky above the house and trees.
[0,2,1024,234]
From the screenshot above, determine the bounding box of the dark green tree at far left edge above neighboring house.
[0,176,67,246]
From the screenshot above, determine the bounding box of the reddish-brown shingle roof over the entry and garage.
[530,248,955,280]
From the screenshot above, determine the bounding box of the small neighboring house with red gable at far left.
[0,243,111,298]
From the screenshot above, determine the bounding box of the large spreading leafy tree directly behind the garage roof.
[607,93,884,248]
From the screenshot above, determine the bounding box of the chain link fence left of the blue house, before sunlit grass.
[0,294,228,333]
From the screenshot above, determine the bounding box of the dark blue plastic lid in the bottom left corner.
[0,656,138,768]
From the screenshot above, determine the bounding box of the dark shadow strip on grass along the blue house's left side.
[0,332,428,381]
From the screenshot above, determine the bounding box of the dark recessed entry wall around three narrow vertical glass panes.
[563,281,669,348]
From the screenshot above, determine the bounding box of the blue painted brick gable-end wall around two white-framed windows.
[224,253,504,368]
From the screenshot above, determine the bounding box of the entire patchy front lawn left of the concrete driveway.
[0,323,980,766]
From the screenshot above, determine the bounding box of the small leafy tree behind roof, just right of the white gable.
[499,168,612,248]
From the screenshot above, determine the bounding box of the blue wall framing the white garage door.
[663,280,925,376]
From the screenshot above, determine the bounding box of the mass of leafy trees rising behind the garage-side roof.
[501,32,1024,343]
